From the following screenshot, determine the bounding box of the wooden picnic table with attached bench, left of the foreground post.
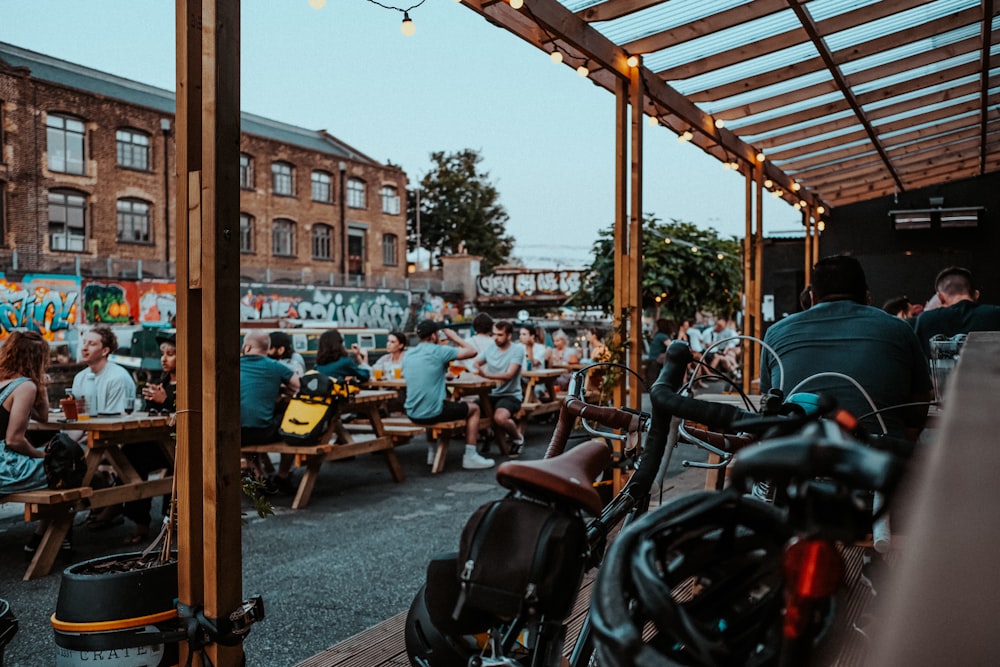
[14,412,174,581]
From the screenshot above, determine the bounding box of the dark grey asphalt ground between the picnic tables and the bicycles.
[0,402,704,667]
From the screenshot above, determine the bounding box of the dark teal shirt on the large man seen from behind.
[760,301,931,436]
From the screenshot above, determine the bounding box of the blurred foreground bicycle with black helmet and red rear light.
[591,350,912,667]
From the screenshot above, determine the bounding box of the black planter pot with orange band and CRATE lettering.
[52,553,178,667]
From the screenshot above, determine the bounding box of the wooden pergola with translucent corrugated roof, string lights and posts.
[176,0,1000,665]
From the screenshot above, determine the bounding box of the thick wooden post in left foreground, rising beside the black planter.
[175,0,243,666]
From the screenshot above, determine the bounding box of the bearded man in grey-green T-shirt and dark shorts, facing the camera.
[476,320,525,456]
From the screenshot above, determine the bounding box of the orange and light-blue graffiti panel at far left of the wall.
[0,274,80,341]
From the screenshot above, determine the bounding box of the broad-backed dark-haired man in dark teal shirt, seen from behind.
[760,255,931,440]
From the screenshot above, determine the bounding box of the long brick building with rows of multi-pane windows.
[0,43,406,286]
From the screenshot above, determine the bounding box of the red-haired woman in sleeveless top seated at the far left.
[0,331,79,557]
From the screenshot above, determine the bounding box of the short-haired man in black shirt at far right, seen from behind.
[911,266,1000,358]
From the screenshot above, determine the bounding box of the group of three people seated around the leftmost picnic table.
[0,325,177,556]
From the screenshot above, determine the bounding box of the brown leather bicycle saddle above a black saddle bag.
[497,440,611,516]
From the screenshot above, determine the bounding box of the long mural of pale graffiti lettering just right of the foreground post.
[240,285,410,329]
